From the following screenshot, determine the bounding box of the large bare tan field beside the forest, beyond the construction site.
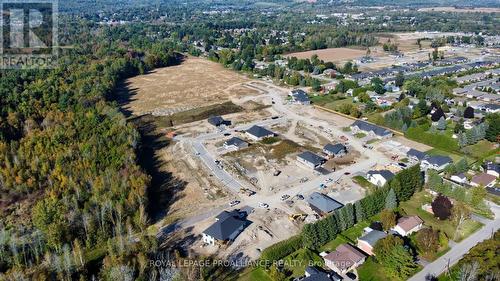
[118,57,256,115]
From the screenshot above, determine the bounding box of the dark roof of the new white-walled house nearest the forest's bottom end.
[203,211,248,240]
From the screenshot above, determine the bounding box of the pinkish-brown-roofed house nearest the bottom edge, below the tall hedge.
[323,244,366,274]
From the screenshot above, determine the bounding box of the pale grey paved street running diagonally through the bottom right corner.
[409,203,500,281]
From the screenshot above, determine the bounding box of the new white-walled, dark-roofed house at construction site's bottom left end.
[202,210,250,245]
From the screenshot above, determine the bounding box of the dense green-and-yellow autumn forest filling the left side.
[0,19,184,280]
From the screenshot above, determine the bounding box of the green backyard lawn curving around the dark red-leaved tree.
[400,191,482,242]
